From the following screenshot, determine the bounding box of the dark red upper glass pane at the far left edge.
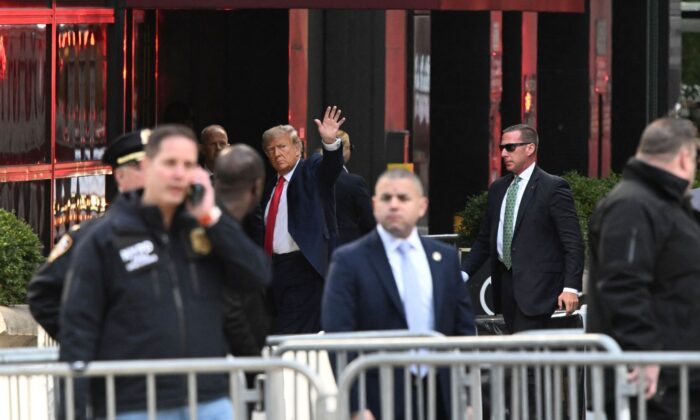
[0,25,51,165]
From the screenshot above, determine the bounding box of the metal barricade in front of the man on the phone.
[0,358,336,420]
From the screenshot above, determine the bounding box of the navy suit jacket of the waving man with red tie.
[263,147,343,277]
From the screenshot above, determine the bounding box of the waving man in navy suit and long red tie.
[262,107,345,334]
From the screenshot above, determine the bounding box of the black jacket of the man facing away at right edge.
[587,159,700,351]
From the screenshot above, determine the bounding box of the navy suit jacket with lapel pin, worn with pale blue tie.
[321,230,475,418]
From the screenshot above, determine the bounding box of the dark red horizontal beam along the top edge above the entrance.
[125,0,585,13]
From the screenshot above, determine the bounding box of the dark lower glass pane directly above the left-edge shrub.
[0,181,51,253]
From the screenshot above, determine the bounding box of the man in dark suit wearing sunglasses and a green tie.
[462,124,584,333]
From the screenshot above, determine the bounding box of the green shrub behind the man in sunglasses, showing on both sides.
[457,171,620,250]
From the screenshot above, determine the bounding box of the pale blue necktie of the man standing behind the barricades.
[397,241,433,377]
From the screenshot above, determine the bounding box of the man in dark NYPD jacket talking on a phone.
[60,125,266,419]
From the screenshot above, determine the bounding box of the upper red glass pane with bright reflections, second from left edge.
[56,24,107,162]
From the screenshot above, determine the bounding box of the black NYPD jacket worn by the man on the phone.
[60,193,269,416]
